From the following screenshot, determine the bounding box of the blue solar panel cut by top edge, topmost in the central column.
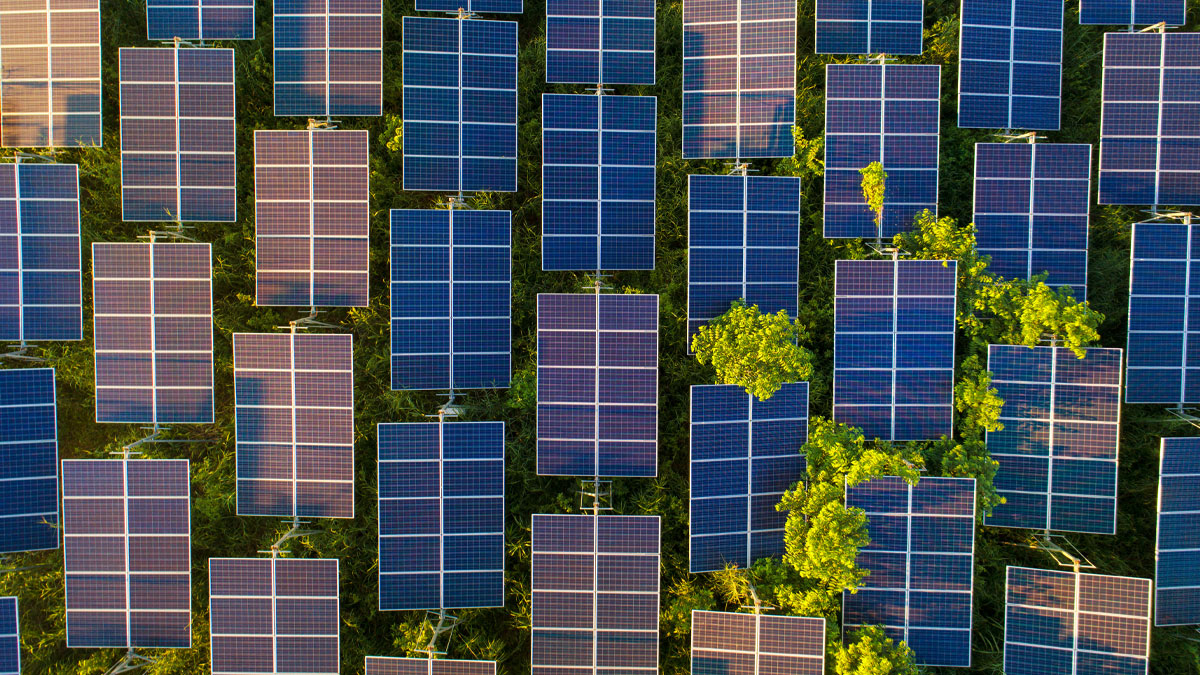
[546,0,654,84]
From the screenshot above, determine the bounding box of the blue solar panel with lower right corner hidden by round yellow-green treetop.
[688,175,800,343]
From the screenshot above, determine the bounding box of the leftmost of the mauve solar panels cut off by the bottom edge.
[209,557,341,675]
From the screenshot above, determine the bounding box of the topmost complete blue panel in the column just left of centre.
[403,17,517,192]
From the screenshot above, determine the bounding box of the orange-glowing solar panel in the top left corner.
[0,0,103,148]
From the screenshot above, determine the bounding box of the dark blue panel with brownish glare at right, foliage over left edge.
[984,345,1121,534]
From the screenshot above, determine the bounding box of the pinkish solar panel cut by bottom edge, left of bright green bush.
[691,609,824,675]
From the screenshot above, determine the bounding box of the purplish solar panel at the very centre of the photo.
[538,293,659,477]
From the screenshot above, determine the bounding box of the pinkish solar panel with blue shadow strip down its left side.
[233,333,354,518]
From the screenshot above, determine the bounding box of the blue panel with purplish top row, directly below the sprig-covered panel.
[833,261,958,441]
